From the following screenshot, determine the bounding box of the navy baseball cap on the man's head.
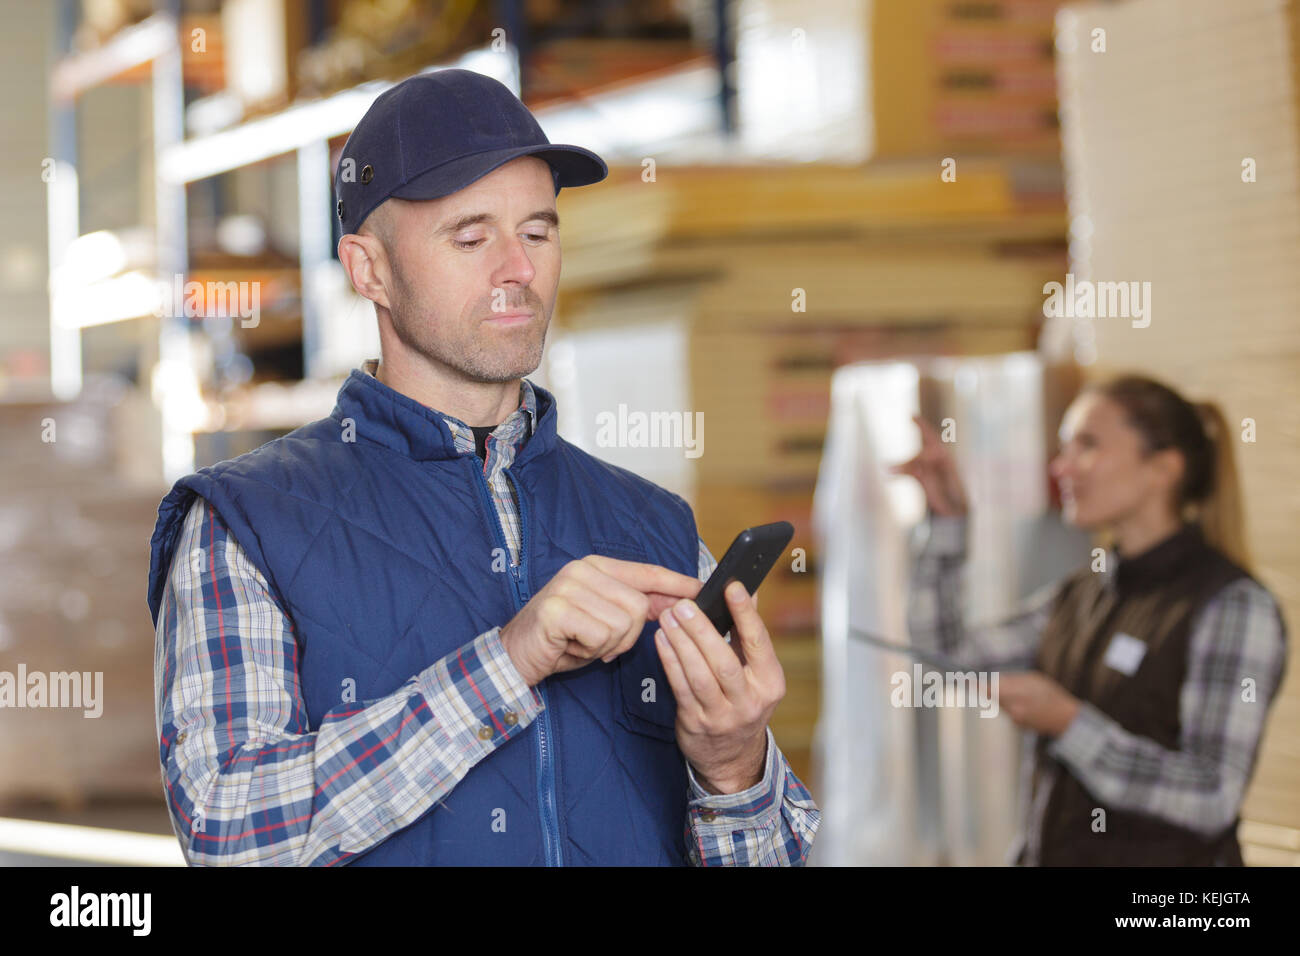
[334,69,610,235]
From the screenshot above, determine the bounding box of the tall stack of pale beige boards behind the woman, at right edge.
[1060,0,1300,862]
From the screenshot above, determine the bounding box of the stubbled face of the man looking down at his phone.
[371,156,560,382]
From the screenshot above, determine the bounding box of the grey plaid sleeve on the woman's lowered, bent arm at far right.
[1048,579,1287,836]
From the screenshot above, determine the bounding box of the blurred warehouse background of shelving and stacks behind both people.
[0,0,1300,865]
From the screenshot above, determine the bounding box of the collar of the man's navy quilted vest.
[330,368,556,464]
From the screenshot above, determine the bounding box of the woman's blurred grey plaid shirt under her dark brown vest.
[907,515,1286,866]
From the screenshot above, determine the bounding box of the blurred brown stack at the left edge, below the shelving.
[0,388,165,806]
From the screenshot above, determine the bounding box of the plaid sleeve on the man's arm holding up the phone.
[686,538,822,866]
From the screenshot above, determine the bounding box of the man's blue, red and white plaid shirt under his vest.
[153,359,820,866]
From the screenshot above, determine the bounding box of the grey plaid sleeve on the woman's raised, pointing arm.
[907,515,1061,670]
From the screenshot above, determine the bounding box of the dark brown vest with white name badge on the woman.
[1031,523,1248,866]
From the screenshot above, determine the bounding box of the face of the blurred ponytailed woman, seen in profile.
[1050,392,1180,531]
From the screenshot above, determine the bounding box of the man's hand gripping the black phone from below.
[655,581,785,793]
